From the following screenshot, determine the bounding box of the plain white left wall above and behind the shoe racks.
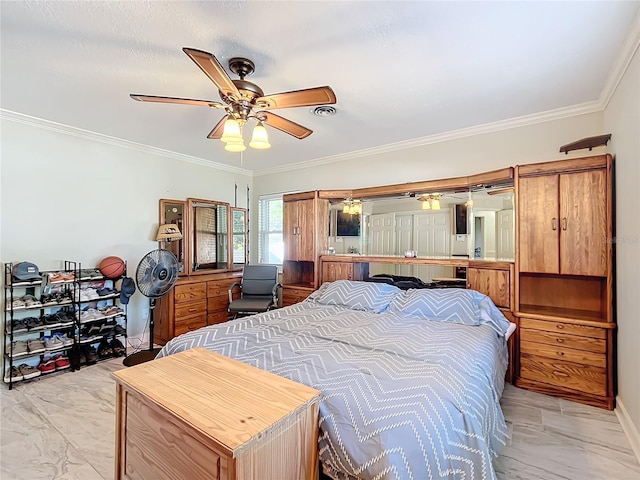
[0,117,252,336]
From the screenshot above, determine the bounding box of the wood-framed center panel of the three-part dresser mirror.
[187,198,229,274]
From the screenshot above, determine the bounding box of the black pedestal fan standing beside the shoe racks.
[122,248,180,367]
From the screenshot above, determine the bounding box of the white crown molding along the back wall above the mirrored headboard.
[254,100,603,177]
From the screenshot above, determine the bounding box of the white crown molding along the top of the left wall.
[0,108,254,177]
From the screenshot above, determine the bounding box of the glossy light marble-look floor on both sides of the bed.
[0,359,640,480]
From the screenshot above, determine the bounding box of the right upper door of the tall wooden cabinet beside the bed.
[560,170,607,276]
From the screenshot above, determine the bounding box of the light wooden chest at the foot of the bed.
[113,348,320,480]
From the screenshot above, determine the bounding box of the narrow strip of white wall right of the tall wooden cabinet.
[604,44,640,450]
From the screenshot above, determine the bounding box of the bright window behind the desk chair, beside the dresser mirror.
[258,194,284,265]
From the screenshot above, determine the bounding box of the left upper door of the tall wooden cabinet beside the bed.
[518,175,560,273]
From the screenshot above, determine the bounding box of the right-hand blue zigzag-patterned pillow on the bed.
[389,288,485,325]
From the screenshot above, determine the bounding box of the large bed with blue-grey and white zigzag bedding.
[159,280,512,480]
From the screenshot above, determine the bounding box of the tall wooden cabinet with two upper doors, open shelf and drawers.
[516,155,615,409]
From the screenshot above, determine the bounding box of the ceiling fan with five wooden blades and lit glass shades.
[130,47,336,152]
